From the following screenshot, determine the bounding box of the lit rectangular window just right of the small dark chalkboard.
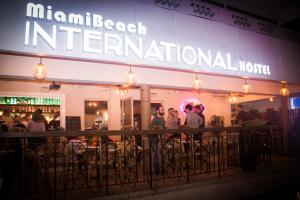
[84,101,109,130]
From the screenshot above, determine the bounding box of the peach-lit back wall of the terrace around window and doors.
[0,80,239,130]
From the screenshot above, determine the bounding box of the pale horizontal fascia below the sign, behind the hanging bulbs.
[0,54,300,95]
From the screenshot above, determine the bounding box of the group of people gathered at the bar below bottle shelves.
[0,109,60,132]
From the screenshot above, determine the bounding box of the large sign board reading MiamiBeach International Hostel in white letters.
[0,0,298,80]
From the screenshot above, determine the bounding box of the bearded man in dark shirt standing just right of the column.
[149,105,166,174]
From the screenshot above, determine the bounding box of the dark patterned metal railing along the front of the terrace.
[0,126,272,199]
